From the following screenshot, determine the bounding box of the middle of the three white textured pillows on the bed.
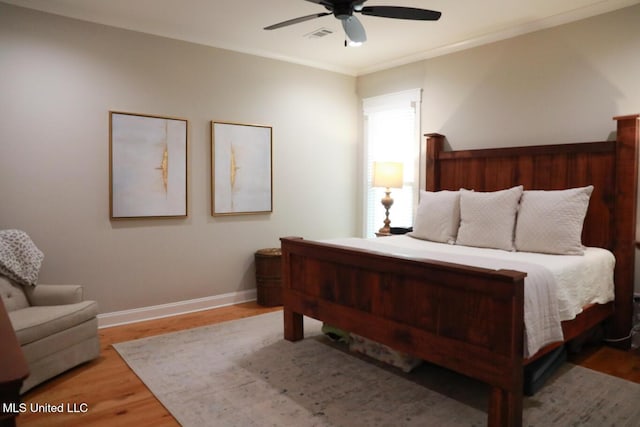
[456,185,522,251]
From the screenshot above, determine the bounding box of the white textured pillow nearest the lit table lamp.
[409,190,460,243]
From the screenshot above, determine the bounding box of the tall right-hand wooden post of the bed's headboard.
[607,114,640,349]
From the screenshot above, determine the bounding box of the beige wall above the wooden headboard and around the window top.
[357,5,640,292]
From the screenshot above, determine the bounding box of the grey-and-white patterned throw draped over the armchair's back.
[0,230,44,286]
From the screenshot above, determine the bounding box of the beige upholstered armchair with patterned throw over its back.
[0,230,100,393]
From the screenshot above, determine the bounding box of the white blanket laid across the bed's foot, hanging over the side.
[323,237,563,357]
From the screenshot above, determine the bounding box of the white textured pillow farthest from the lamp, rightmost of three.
[515,185,593,255]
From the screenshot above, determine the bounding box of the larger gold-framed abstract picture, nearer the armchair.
[109,111,189,220]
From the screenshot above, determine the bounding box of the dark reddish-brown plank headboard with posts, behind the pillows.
[426,115,640,348]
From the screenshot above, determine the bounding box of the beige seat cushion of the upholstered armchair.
[9,301,98,345]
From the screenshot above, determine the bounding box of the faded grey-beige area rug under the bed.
[114,312,640,427]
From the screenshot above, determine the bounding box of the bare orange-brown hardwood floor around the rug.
[12,303,640,427]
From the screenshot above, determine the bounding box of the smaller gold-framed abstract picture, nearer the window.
[211,121,273,216]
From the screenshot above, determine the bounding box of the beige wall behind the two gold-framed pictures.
[0,3,358,313]
